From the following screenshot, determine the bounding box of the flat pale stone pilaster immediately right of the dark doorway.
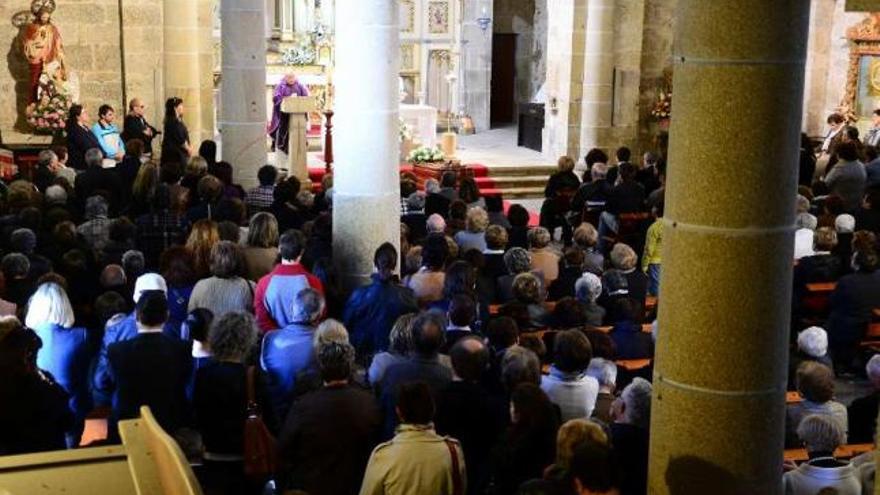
[543,0,587,161]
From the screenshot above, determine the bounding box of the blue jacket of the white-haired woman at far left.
[34,323,92,422]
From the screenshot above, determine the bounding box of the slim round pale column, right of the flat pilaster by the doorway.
[574,0,616,157]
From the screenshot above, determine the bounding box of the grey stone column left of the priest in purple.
[220,0,266,186]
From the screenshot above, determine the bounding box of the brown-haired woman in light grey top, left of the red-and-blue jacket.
[189,241,255,318]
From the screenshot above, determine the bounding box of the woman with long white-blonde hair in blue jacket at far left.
[25,282,93,448]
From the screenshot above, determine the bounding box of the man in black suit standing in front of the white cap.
[107,290,192,439]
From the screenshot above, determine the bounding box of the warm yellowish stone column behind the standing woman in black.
[161,0,202,143]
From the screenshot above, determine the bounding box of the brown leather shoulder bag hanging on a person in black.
[243,366,277,480]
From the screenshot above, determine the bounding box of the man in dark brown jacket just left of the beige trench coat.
[278,342,382,494]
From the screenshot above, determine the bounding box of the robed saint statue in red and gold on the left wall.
[21,0,67,103]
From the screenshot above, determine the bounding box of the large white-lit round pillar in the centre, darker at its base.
[333,0,400,289]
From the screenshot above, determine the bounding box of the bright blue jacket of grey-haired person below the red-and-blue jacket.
[260,323,316,418]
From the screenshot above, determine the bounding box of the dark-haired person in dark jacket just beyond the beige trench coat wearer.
[379,312,452,439]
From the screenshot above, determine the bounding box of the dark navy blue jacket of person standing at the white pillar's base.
[342,275,419,359]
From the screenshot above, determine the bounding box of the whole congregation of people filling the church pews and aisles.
[0,98,880,495]
